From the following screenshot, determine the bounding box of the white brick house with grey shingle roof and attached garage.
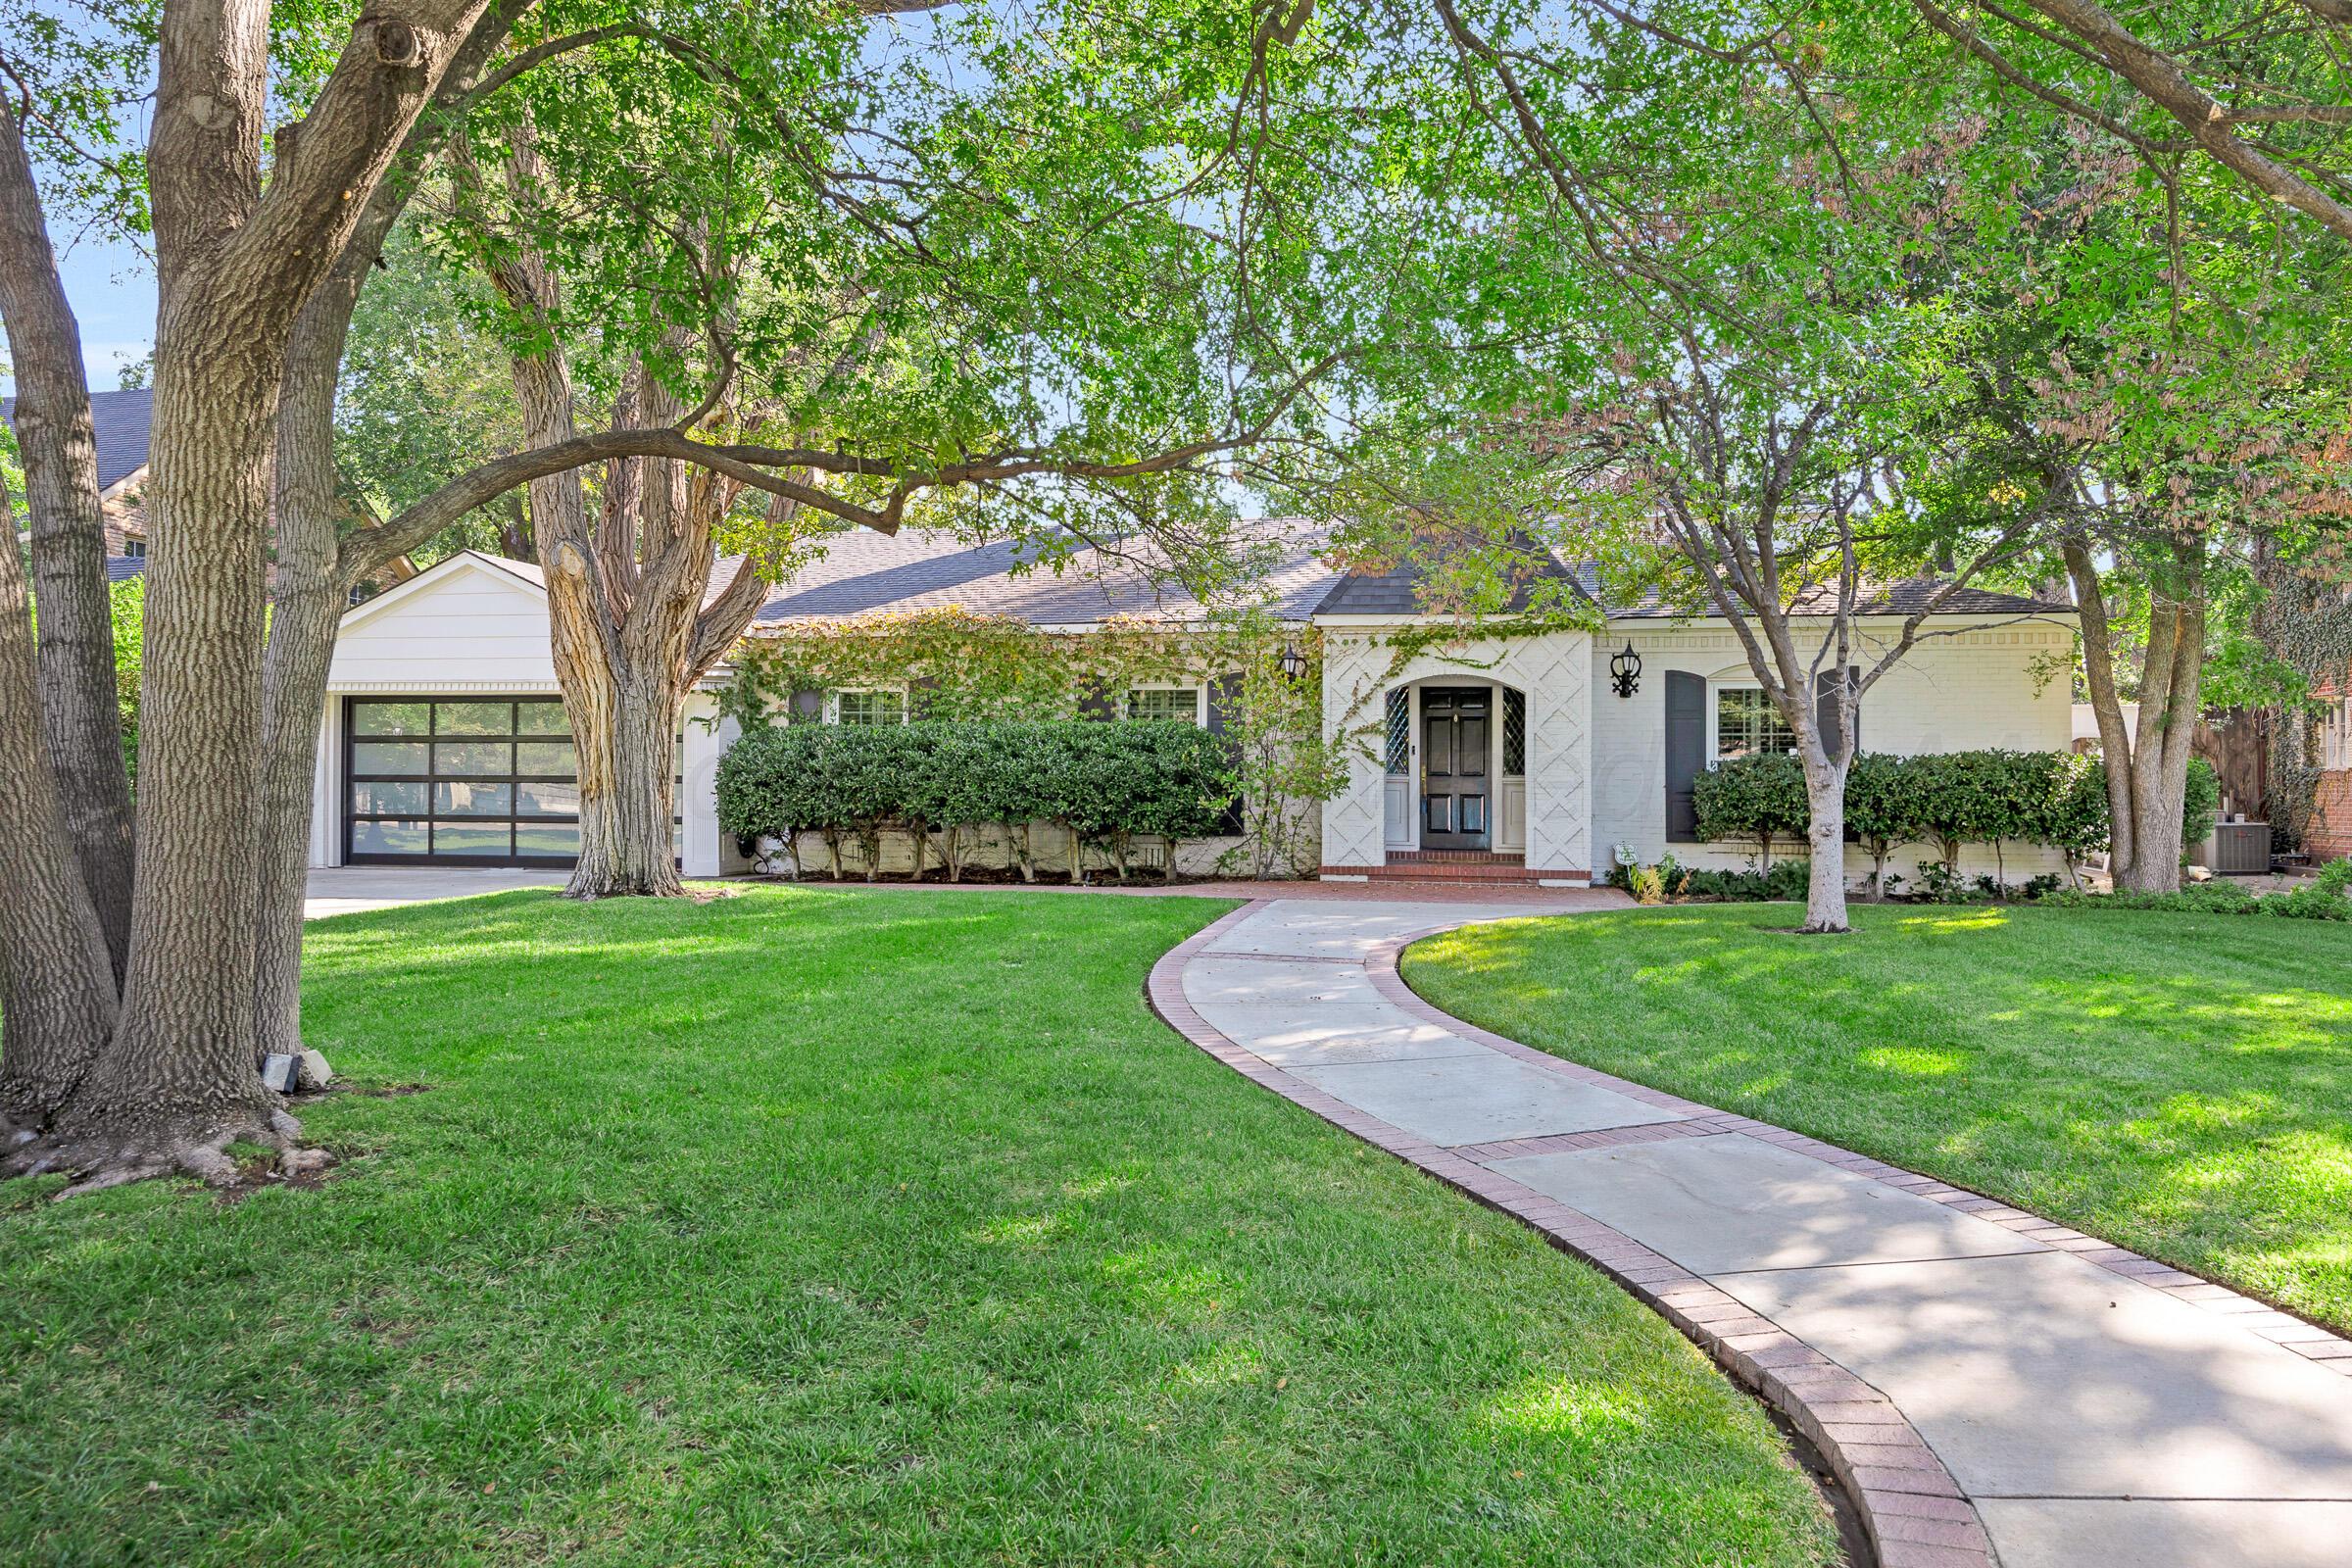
[311,531,2075,886]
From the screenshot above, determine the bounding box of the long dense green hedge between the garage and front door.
[717,719,1233,882]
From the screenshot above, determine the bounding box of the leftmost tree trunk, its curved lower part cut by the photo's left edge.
[0,503,116,1128]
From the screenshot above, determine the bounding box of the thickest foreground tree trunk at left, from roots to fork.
[59,291,292,1178]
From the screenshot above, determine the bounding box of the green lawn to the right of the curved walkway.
[1404,906,2352,1331]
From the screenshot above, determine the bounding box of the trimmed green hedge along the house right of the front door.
[1691,750,2221,879]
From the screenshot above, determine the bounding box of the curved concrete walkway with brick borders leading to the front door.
[1151,898,2352,1568]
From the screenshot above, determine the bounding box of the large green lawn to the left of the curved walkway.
[0,889,1833,1568]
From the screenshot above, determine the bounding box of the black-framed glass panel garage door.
[343,698,581,865]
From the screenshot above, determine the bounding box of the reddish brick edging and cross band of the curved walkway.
[1146,898,2352,1568]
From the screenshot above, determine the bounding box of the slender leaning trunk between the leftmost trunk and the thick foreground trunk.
[0,104,131,983]
